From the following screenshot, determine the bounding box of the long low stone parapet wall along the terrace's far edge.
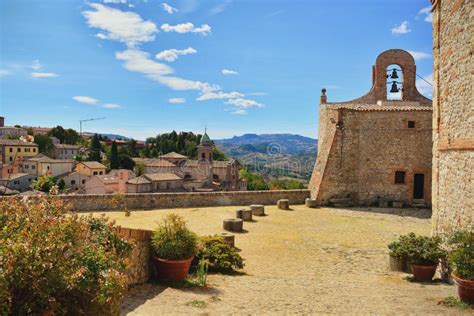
[14,190,310,211]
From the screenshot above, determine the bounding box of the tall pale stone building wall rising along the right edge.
[432,0,474,234]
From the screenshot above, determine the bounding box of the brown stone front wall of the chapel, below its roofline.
[312,104,432,205]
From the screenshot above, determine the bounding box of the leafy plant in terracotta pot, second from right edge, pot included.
[407,233,445,281]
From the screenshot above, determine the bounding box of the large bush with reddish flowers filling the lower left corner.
[0,197,131,315]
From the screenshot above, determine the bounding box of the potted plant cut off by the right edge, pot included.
[448,230,474,304]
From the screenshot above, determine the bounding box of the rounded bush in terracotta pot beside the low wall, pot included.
[151,214,197,281]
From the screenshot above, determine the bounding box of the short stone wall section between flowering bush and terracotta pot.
[117,227,153,286]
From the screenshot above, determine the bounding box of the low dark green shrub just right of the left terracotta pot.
[196,236,244,272]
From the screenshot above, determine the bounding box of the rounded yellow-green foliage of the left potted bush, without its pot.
[151,214,197,260]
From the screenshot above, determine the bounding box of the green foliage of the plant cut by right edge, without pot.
[448,230,474,280]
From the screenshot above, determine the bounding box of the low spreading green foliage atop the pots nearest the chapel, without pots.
[389,233,446,265]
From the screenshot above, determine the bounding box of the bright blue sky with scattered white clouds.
[0,0,432,139]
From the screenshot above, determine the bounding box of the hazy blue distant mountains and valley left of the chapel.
[214,134,318,181]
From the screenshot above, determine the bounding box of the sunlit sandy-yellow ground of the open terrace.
[83,205,469,315]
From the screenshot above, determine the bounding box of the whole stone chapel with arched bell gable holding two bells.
[310,49,432,206]
